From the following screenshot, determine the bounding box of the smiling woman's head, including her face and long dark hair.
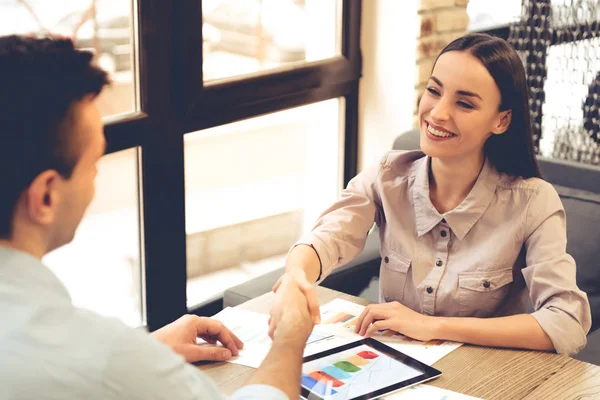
[419,35,540,178]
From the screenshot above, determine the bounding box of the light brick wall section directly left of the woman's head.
[413,0,469,127]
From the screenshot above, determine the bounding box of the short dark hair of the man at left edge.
[0,35,109,238]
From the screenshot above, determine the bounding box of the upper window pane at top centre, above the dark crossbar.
[202,0,342,81]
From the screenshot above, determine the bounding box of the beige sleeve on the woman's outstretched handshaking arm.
[292,155,387,282]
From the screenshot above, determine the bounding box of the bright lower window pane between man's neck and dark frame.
[44,149,144,326]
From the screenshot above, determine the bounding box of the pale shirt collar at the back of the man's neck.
[0,246,71,303]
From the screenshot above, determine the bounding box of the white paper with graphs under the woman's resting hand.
[321,299,462,365]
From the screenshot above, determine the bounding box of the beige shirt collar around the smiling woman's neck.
[413,156,500,241]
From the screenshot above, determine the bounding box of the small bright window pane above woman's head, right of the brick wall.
[467,0,522,31]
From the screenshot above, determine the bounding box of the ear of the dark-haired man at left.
[24,170,61,225]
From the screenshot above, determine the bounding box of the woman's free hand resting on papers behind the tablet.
[354,301,437,341]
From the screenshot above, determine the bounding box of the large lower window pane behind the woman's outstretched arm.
[185,99,344,306]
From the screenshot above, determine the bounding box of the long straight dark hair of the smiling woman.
[436,33,541,178]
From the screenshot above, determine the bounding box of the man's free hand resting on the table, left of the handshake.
[152,315,244,363]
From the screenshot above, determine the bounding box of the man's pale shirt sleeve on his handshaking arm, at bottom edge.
[104,329,287,400]
